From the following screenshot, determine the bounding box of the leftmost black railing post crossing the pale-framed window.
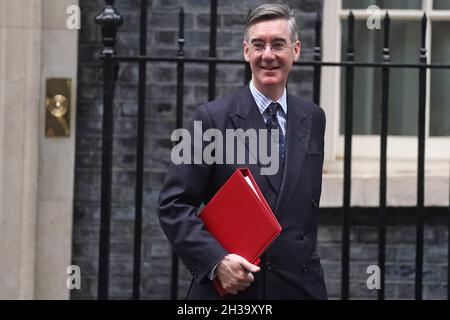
[341,11,355,300]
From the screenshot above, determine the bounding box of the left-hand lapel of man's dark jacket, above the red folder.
[230,85,279,194]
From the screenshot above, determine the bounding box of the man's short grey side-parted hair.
[244,3,299,42]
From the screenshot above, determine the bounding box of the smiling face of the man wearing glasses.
[244,19,300,90]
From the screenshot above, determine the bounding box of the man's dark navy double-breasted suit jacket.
[159,86,327,299]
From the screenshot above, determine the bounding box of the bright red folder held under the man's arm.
[199,168,281,296]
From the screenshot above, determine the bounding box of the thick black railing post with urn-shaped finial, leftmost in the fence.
[95,0,123,299]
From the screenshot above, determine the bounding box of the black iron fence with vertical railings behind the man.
[95,0,450,299]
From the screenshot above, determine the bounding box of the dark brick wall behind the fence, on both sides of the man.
[72,0,447,299]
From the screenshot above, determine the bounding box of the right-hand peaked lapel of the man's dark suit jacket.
[275,95,312,217]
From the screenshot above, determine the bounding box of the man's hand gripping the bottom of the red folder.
[216,254,260,294]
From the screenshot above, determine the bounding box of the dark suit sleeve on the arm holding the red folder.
[158,106,228,283]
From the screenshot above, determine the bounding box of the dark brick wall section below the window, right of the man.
[318,208,448,299]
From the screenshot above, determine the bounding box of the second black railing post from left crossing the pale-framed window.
[378,12,391,300]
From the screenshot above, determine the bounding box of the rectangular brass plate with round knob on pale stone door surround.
[45,78,72,137]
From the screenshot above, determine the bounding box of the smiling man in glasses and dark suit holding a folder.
[159,4,327,299]
